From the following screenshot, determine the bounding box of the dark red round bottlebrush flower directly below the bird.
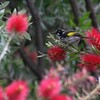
[48,46,66,61]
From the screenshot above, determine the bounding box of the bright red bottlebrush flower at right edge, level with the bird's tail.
[86,28,100,50]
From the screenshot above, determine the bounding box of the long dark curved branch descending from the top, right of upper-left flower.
[26,0,44,73]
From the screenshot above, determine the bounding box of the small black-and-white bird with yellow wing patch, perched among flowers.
[55,29,87,48]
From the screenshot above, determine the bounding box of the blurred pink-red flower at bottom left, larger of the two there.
[6,81,29,100]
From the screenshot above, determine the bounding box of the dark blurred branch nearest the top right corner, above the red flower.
[85,0,98,28]
